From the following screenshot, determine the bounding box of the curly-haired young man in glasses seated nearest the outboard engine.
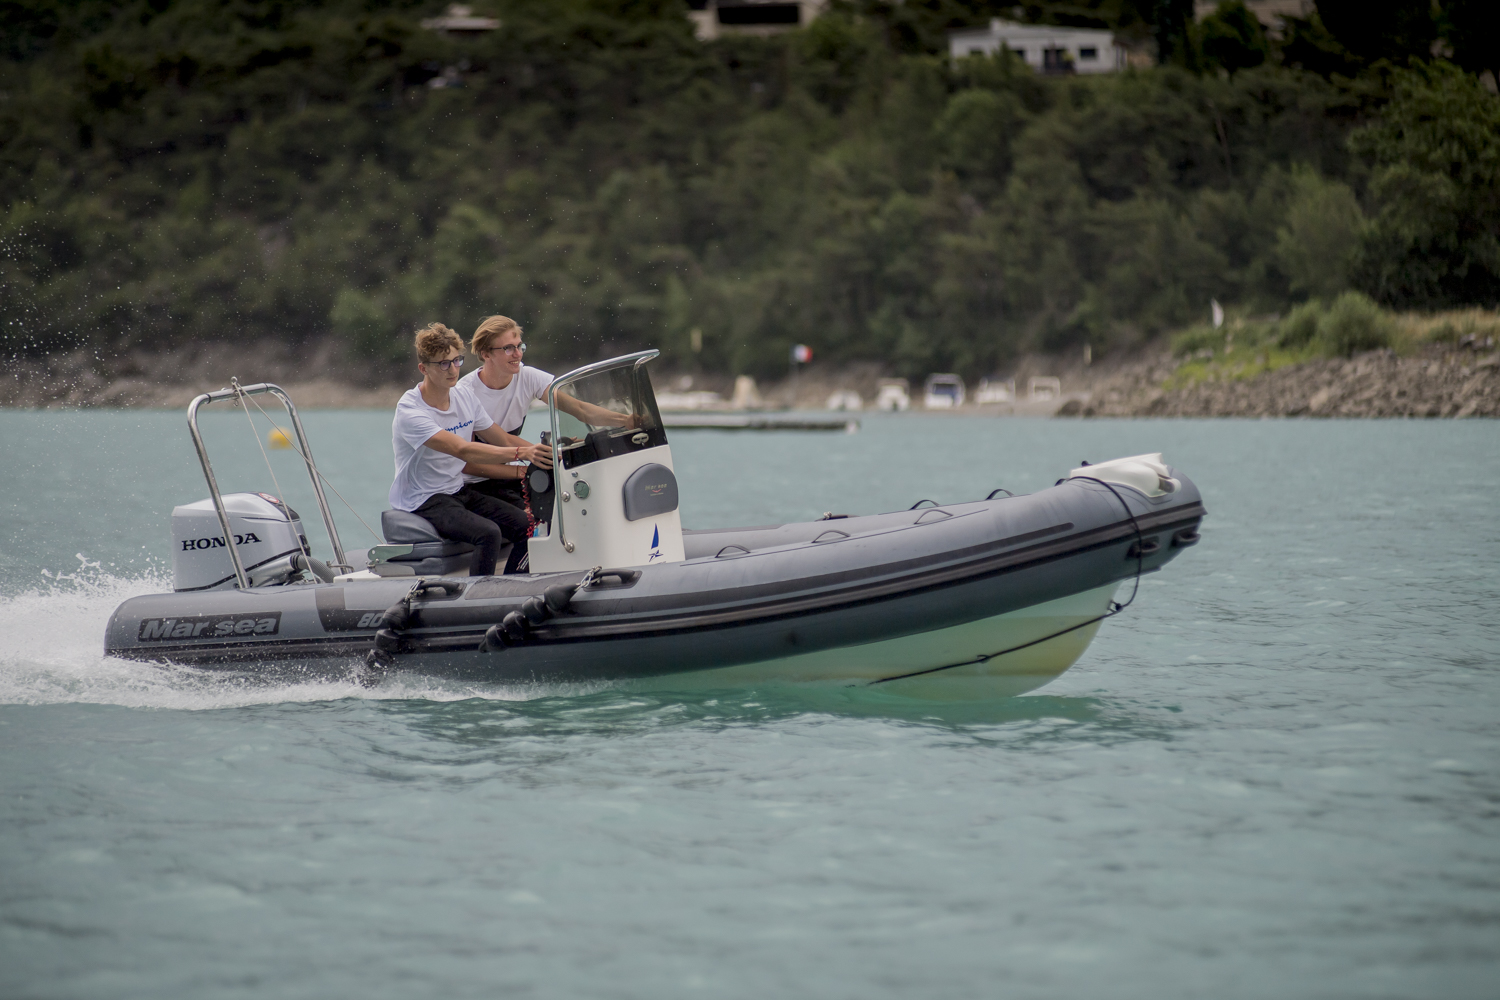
[390,322,552,576]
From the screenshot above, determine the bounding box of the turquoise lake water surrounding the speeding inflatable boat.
[0,411,1500,1000]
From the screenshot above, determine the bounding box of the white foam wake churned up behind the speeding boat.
[0,556,609,711]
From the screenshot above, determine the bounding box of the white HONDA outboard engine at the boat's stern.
[173,493,308,591]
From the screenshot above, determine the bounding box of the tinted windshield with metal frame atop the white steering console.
[552,360,666,469]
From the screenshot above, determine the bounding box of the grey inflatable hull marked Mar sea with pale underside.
[105,480,1203,699]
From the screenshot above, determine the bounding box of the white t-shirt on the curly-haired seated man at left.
[390,382,495,511]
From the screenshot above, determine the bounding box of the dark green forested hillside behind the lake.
[0,0,1500,375]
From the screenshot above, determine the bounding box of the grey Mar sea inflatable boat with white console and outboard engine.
[105,351,1205,699]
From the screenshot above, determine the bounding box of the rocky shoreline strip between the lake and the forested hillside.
[0,335,1500,418]
